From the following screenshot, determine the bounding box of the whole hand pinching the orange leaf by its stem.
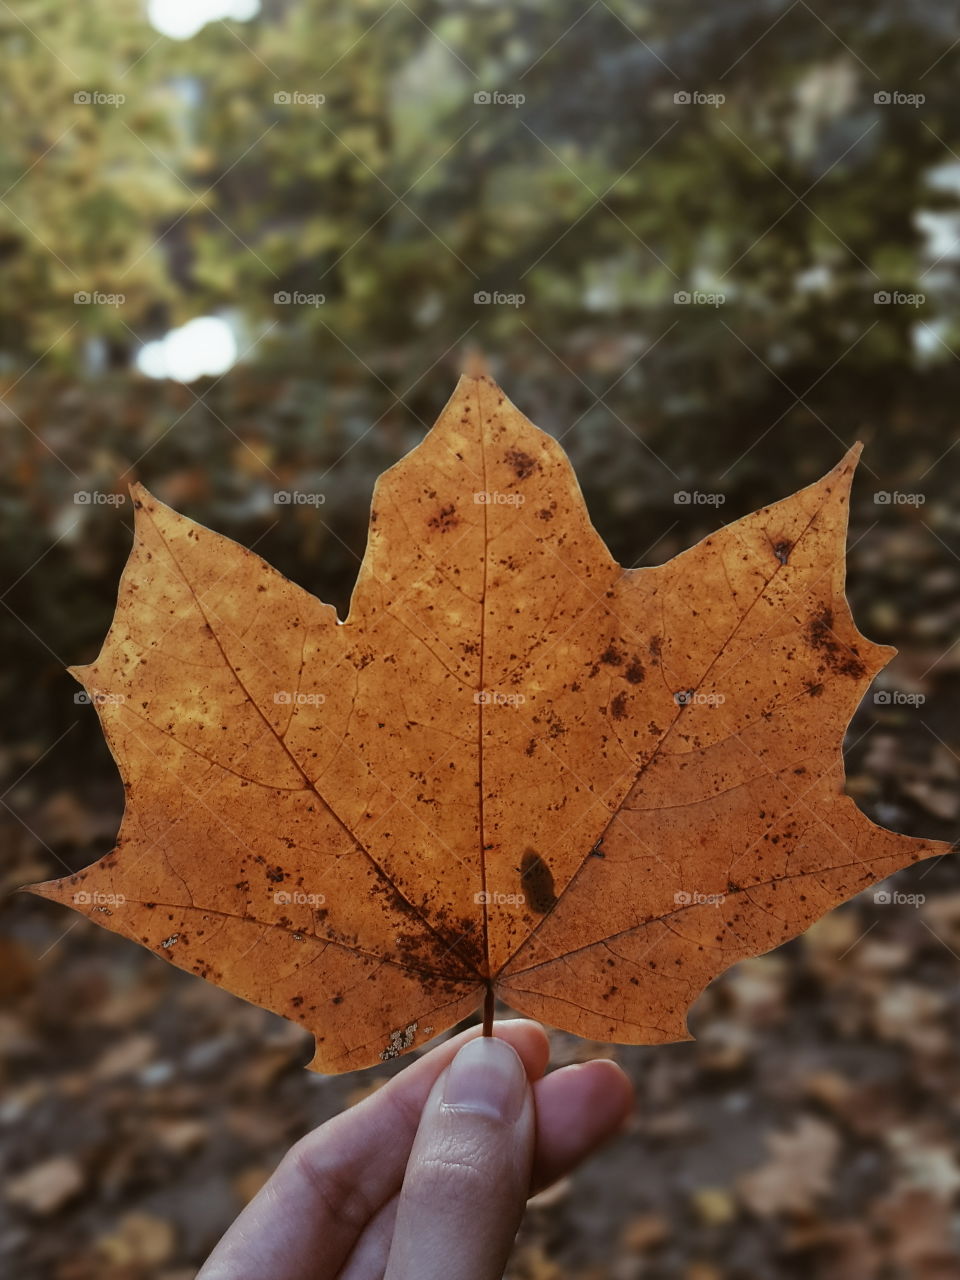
[197,1020,632,1280]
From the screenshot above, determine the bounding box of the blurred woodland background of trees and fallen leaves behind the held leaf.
[0,0,960,1280]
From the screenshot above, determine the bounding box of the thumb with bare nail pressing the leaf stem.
[384,1036,536,1280]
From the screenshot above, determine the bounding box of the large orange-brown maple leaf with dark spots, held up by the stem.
[26,376,948,1071]
